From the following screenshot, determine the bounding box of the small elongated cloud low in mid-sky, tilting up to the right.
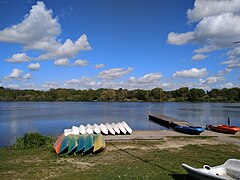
[97,67,133,79]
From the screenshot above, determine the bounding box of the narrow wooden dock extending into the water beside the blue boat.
[148,114,190,128]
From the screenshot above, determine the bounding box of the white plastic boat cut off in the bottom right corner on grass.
[182,159,240,180]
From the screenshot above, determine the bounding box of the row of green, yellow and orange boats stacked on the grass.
[53,133,106,155]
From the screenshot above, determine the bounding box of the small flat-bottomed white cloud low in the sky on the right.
[173,68,207,78]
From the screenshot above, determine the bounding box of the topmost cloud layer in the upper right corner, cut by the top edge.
[187,0,240,22]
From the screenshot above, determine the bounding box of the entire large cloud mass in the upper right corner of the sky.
[167,0,240,53]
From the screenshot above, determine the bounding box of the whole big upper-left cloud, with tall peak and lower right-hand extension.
[0,2,91,62]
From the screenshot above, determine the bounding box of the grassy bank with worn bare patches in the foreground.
[0,137,240,179]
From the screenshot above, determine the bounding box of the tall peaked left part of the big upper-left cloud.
[0,2,61,48]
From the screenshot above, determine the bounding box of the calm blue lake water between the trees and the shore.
[0,102,240,147]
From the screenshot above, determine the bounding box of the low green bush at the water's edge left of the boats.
[13,133,53,149]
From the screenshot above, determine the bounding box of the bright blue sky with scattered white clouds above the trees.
[0,0,240,91]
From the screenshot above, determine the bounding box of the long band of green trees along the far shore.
[0,87,240,102]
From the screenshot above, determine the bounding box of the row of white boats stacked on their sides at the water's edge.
[64,121,132,136]
